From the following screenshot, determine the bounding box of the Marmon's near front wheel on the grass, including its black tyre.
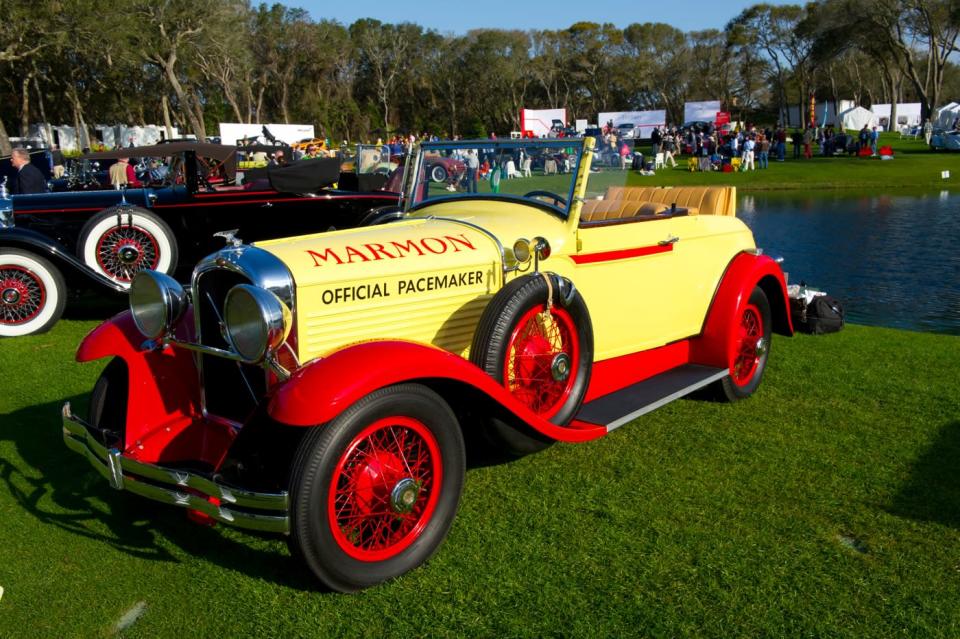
[290,384,466,592]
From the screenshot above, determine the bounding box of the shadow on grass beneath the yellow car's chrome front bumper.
[0,397,322,591]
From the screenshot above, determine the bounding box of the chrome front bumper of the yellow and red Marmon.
[62,402,290,533]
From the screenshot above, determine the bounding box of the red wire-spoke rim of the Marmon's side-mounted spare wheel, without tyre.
[504,304,580,419]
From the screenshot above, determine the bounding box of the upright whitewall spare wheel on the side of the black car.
[77,206,177,286]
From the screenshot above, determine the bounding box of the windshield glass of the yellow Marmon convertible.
[406,138,583,216]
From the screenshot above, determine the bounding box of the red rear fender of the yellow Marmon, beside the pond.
[691,253,793,368]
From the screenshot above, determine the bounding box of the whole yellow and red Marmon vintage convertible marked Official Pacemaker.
[63,138,792,591]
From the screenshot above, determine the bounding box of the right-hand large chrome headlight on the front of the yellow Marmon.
[223,284,292,364]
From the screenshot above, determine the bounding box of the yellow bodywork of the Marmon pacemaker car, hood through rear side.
[257,190,754,361]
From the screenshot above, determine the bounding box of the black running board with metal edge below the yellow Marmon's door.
[576,364,730,432]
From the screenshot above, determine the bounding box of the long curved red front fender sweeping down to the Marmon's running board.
[267,341,607,442]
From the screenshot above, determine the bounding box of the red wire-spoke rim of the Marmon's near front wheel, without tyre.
[329,415,443,561]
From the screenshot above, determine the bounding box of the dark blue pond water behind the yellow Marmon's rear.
[737,191,960,335]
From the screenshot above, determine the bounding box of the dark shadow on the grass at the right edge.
[889,421,960,529]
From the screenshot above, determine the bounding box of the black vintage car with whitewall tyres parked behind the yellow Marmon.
[0,142,400,337]
